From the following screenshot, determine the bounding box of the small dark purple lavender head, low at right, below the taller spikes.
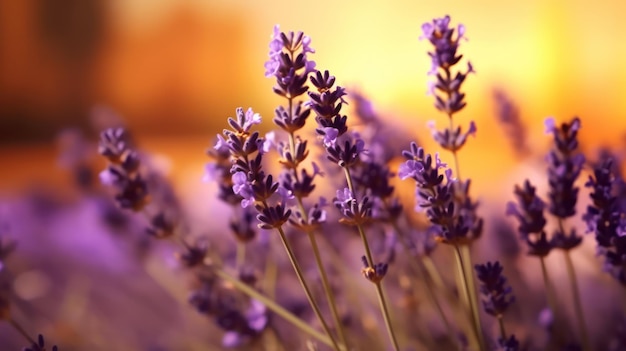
[474,261,515,318]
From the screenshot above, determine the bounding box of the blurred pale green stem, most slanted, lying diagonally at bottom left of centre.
[214,268,344,350]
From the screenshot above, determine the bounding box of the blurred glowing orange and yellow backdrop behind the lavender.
[0,0,626,350]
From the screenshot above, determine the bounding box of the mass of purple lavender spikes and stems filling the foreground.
[0,16,626,351]
